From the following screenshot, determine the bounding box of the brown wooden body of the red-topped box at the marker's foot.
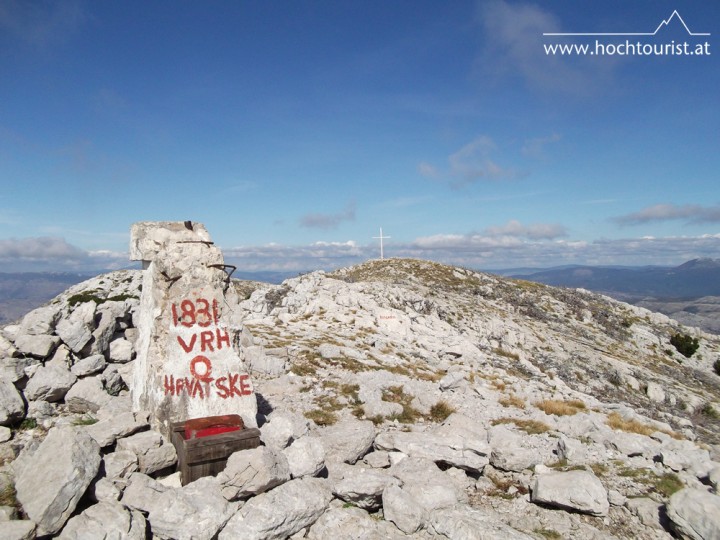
[171,422,260,486]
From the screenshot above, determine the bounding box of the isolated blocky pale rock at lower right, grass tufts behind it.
[530,471,610,516]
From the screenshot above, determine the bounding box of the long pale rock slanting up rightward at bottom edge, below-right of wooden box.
[218,477,332,540]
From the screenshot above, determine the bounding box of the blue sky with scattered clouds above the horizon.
[0,0,720,271]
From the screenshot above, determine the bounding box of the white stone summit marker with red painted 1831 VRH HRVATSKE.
[130,221,257,435]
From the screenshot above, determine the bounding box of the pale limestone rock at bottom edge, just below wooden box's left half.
[148,476,236,540]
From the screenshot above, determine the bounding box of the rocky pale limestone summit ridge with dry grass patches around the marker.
[0,259,720,540]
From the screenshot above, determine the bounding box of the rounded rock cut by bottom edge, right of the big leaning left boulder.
[58,501,146,540]
